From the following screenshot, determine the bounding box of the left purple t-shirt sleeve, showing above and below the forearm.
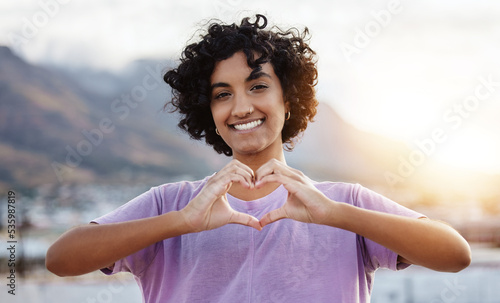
[92,188,162,275]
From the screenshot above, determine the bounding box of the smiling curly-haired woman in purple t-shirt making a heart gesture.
[46,15,470,302]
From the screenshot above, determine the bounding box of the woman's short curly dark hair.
[163,15,318,156]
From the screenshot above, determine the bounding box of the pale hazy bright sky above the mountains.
[0,0,500,173]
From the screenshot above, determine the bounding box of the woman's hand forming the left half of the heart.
[181,160,262,232]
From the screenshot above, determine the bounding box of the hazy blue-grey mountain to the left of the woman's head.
[0,47,225,192]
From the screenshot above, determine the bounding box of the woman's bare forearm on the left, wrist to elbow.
[46,212,189,276]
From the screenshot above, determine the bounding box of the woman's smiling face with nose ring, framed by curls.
[210,52,288,158]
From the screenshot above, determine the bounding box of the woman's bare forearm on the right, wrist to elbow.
[328,203,470,272]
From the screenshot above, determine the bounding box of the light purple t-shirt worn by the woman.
[94,178,422,303]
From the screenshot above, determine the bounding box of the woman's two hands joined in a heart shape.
[181,159,335,232]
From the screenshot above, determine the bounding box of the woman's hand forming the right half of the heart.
[255,159,335,227]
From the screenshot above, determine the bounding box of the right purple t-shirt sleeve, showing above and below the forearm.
[353,184,425,270]
